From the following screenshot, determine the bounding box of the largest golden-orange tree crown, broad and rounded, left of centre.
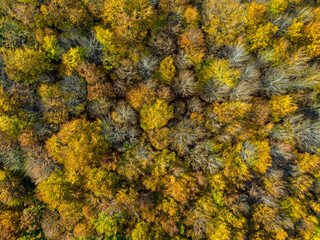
[46,119,108,174]
